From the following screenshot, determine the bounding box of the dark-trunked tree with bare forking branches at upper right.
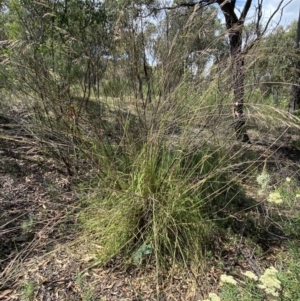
[154,0,284,142]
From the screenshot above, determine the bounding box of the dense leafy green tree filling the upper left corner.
[5,0,116,106]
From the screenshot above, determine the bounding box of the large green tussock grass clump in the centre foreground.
[81,138,241,263]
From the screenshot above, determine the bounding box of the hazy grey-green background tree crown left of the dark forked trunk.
[155,6,221,93]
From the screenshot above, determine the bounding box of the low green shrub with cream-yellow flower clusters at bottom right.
[206,173,300,301]
